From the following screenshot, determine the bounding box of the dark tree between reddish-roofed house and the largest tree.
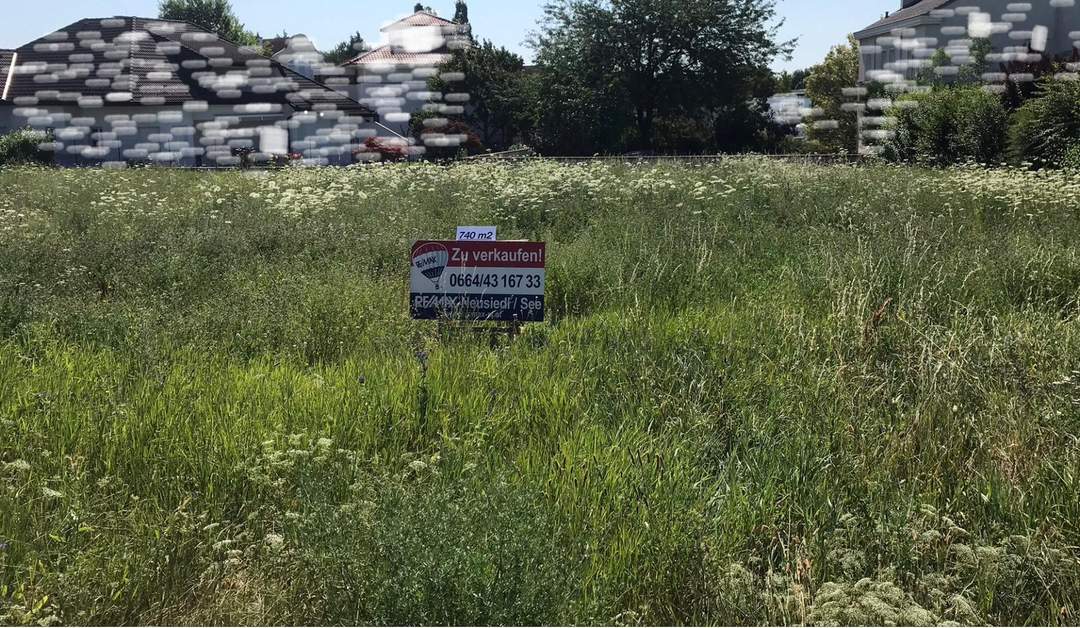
[431,41,529,149]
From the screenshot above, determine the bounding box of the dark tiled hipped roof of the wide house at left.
[9,16,375,117]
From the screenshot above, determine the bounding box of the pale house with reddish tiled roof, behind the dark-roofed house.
[320,10,472,143]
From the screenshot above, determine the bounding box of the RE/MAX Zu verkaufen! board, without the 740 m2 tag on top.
[409,241,546,322]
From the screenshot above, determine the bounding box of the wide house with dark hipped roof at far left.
[0,16,384,165]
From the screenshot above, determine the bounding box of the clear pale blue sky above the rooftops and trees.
[0,0,900,69]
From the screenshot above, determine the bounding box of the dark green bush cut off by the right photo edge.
[1009,79,1080,168]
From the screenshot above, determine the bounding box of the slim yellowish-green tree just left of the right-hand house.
[807,35,859,153]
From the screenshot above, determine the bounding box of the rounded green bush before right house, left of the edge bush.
[885,86,1009,165]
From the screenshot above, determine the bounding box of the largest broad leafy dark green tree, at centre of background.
[534,0,791,150]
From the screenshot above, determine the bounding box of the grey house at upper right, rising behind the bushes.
[854,0,1080,83]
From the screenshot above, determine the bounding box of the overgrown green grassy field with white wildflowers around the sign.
[0,159,1080,625]
